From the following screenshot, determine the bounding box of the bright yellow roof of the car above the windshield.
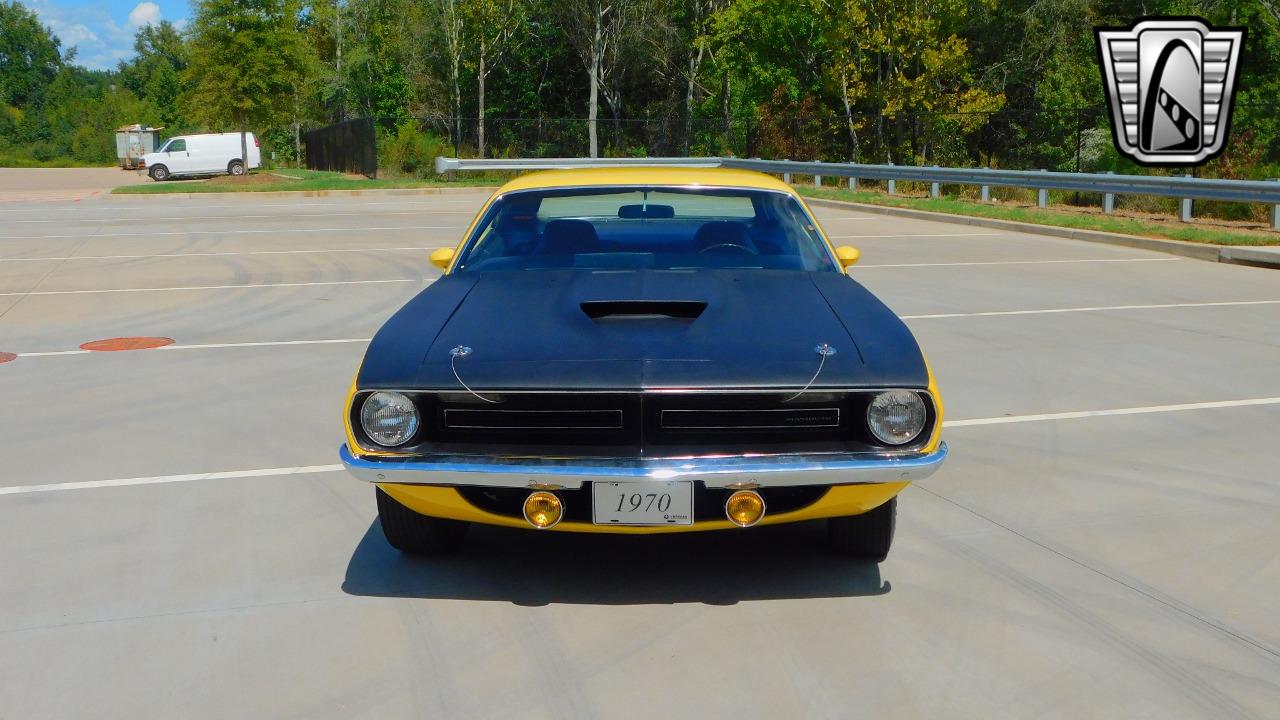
[498,167,795,195]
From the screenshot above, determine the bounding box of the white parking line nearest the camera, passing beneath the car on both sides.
[0,397,1280,495]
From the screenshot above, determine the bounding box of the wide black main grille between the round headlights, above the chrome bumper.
[351,391,936,457]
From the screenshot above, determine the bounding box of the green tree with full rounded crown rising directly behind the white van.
[183,0,315,165]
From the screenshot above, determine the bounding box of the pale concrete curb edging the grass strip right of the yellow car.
[805,197,1280,268]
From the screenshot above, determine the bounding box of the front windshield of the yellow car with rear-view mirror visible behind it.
[456,187,836,272]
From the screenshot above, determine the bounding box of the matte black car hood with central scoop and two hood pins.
[360,269,927,389]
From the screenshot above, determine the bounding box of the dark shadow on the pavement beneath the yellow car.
[342,520,891,606]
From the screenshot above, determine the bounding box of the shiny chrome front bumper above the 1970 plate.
[339,442,947,489]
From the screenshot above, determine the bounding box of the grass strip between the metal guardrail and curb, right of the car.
[796,186,1280,245]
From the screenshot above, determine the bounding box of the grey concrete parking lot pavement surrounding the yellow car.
[0,185,1280,720]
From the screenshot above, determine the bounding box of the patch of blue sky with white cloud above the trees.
[19,0,191,70]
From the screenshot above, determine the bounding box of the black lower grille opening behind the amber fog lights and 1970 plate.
[458,482,829,523]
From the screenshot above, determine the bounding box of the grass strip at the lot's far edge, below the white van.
[113,169,503,195]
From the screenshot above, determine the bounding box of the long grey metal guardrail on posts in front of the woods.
[435,158,1280,229]
